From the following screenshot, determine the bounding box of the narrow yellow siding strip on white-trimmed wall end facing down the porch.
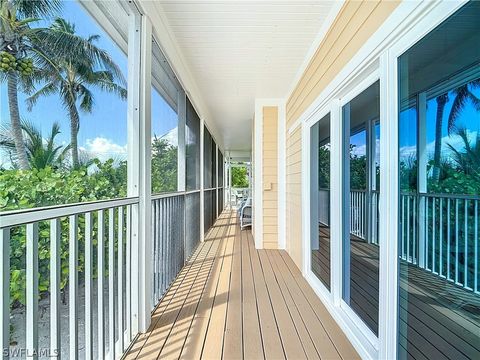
[262,106,278,249]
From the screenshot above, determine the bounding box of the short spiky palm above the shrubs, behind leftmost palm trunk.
[0,121,70,169]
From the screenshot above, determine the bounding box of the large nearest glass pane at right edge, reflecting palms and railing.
[398,1,480,359]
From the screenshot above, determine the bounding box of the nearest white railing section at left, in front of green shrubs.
[0,198,138,359]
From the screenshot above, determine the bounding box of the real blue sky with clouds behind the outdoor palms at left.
[0,1,177,164]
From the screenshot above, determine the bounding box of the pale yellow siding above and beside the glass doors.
[286,1,399,268]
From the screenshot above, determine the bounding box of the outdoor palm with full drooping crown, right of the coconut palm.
[27,18,127,167]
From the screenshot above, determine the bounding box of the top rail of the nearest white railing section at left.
[0,197,138,228]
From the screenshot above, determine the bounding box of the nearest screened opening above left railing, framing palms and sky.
[0,1,128,211]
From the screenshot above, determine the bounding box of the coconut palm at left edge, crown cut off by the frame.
[0,0,62,169]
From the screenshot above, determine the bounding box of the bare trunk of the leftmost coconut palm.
[8,71,30,170]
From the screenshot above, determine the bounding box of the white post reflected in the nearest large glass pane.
[417,92,428,268]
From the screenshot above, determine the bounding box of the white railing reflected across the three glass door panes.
[319,189,480,293]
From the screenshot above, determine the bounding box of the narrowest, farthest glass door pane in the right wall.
[310,114,330,290]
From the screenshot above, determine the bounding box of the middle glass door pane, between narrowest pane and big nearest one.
[342,81,380,335]
